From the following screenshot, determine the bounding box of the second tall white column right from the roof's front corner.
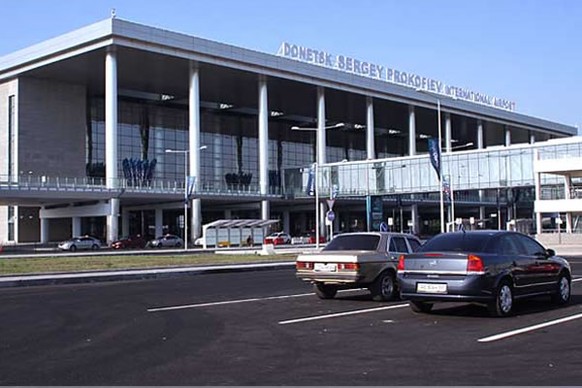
[188,61,204,241]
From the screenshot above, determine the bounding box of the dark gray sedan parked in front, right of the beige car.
[398,230,571,316]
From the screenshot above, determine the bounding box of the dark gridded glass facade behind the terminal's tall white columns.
[86,98,374,194]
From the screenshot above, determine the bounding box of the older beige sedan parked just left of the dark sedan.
[296,232,420,301]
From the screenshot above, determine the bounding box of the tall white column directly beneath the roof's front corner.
[105,46,119,242]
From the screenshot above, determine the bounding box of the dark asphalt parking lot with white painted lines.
[0,259,582,385]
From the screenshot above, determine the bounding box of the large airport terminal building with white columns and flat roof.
[0,18,582,243]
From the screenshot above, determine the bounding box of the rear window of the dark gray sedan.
[419,233,491,252]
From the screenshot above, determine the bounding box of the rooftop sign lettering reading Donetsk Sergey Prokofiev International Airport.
[277,42,515,112]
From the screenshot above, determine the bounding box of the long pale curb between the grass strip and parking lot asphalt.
[0,262,295,288]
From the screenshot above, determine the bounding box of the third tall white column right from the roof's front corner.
[259,75,270,220]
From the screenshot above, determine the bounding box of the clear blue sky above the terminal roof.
[0,0,582,127]
